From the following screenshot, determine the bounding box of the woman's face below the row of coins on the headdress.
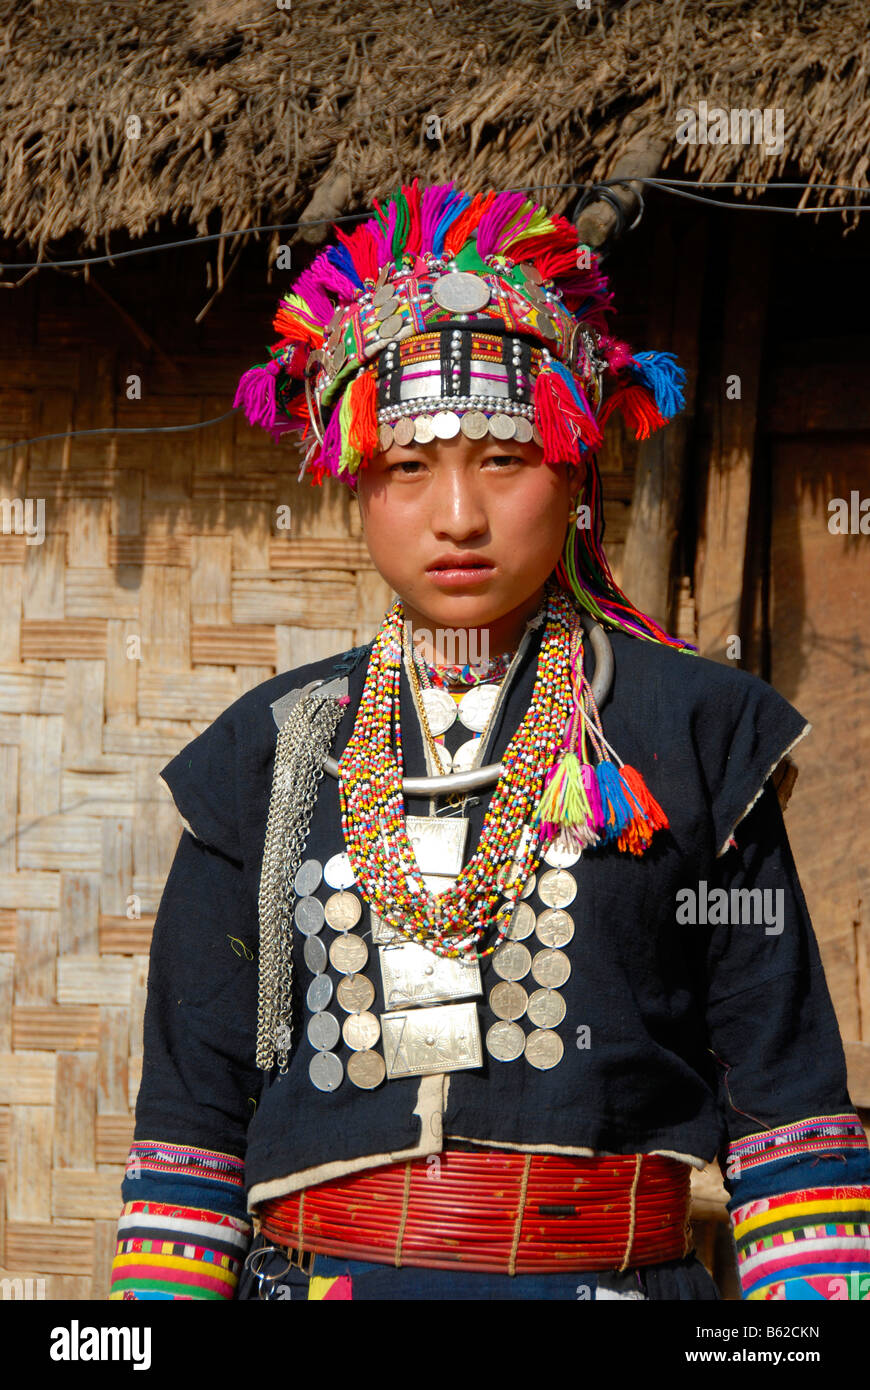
[357,434,580,628]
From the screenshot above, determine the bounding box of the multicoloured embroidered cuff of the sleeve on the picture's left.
[108,1140,252,1300]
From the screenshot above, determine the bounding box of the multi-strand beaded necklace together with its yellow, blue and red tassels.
[339,587,667,959]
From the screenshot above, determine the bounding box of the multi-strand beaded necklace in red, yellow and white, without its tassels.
[339,589,582,959]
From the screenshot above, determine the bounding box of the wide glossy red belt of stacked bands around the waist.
[258,1150,692,1275]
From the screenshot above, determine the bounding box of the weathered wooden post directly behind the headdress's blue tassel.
[621,217,706,630]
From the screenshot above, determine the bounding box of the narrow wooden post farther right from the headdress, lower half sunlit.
[695,217,769,660]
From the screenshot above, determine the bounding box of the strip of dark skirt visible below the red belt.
[236,1234,719,1302]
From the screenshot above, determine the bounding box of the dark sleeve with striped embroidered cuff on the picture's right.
[697,783,870,1300]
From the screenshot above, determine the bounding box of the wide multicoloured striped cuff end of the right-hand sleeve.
[731,1186,870,1300]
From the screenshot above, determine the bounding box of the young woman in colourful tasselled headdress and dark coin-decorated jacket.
[111,182,870,1300]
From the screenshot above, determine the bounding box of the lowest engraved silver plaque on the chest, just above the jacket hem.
[381,1004,484,1081]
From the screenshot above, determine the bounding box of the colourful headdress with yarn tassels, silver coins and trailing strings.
[233,179,689,646]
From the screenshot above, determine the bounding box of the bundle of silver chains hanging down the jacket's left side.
[257,692,343,1074]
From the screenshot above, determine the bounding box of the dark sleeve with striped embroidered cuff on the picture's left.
[110,811,261,1300]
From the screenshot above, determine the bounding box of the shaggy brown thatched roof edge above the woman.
[0,0,870,249]
